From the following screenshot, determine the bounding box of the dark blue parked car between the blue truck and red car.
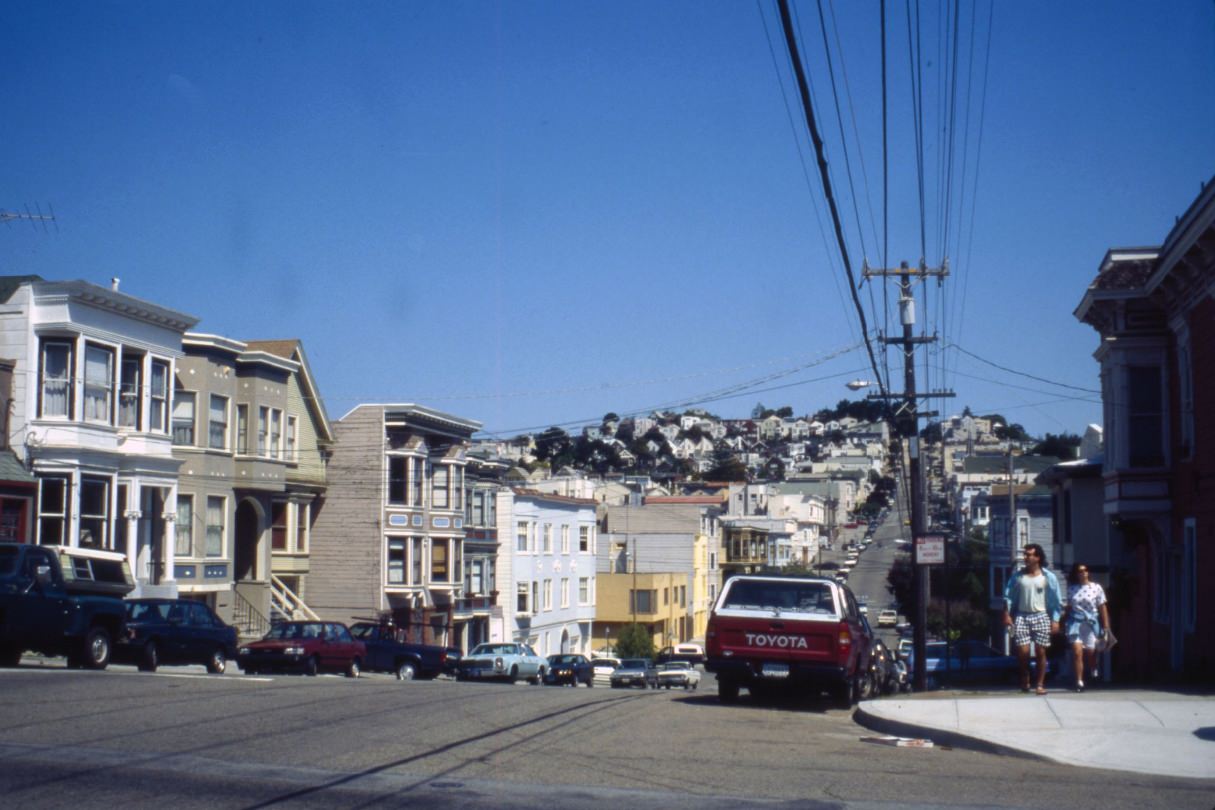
[114,599,236,675]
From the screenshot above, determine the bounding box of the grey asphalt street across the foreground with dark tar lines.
[0,659,1211,809]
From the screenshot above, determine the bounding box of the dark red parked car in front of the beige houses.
[237,622,367,678]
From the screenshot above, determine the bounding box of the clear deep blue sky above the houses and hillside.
[0,0,1215,435]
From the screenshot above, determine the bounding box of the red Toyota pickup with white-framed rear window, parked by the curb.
[705,576,874,708]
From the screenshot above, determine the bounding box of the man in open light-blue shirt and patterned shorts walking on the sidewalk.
[1004,543,1063,695]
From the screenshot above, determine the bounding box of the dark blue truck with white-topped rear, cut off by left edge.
[0,543,135,669]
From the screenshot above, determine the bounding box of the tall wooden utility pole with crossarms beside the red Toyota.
[863,261,954,690]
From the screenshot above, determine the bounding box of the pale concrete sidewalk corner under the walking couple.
[855,687,1215,780]
